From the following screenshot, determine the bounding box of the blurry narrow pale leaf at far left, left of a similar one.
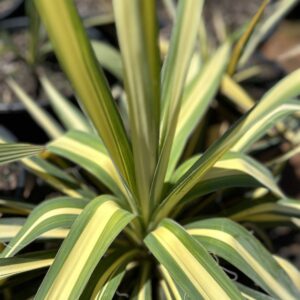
[7,79,63,138]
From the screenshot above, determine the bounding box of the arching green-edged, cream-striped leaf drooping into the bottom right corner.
[187,219,300,299]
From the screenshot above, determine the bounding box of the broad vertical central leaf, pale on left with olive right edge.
[113,0,160,219]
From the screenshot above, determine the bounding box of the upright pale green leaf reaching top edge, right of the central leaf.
[151,0,203,202]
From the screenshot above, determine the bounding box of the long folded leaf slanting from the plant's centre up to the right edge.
[155,70,300,223]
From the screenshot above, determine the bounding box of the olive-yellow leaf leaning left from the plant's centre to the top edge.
[35,0,135,190]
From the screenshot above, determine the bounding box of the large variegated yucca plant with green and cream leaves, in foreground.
[0,0,300,300]
